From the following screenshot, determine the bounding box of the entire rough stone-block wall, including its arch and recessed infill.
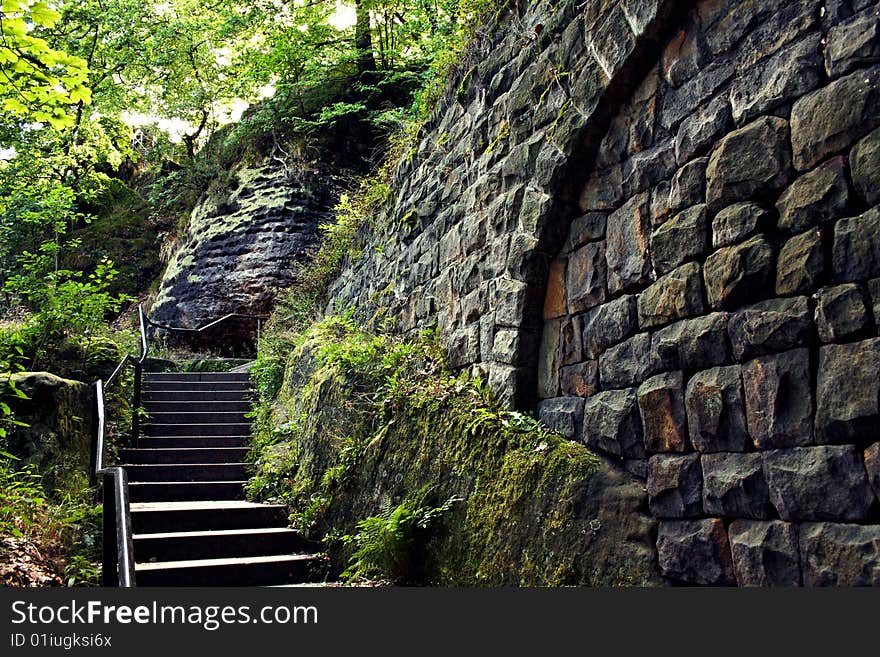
[330,0,880,585]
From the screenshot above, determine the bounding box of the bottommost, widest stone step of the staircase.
[135,554,327,586]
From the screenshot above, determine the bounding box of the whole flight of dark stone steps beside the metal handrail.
[120,372,326,586]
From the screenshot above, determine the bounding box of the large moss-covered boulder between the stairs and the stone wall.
[250,320,658,586]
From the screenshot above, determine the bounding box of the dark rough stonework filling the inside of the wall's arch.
[537,0,880,585]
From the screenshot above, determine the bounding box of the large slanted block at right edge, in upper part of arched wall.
[791,67,880,171]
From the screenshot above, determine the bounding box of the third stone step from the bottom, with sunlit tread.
[131,500,288,534]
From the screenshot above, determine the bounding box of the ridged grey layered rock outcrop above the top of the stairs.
[150,165,336,338]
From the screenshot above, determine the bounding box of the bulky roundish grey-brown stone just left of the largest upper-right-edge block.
[706,117,792,212]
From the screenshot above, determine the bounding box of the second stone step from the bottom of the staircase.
[134,527,315,563]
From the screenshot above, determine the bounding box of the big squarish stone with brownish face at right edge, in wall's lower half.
[816,338,880,443]
